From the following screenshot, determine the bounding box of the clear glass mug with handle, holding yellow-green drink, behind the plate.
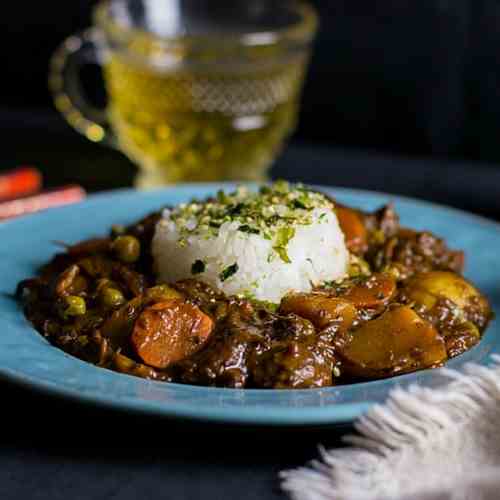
[49,0,317,188]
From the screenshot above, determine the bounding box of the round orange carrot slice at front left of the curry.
[131,299,214,368]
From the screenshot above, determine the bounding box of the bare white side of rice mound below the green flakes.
[152,207,349,303]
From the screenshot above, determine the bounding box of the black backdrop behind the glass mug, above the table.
[0,0,500,161]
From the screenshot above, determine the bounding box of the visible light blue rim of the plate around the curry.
[0,184,500,425]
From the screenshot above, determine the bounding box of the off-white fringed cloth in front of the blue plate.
[281,355,500,500]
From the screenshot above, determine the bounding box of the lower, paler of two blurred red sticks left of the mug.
[0,185,86,220]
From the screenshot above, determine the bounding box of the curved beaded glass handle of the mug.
[49,28,115,146]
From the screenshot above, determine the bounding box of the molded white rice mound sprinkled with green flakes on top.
[152,184,349,303]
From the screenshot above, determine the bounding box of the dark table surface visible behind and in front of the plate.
[0,110,500,500]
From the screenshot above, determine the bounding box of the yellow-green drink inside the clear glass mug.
[104,50,305,187]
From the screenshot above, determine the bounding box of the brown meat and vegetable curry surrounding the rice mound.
[18,198,492,388]
